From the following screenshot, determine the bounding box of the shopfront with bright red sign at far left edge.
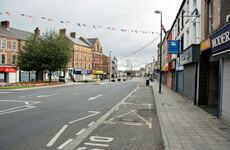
[0,67,17,83]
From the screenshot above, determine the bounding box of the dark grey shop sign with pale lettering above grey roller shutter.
[180,45,200,65]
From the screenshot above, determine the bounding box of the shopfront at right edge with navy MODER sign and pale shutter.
[210,24,230,125]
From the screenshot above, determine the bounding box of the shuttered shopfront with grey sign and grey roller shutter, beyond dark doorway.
[180,44,200,104]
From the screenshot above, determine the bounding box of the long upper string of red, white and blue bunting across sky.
[0,11,159,35]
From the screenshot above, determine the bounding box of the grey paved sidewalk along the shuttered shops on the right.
[150,80,230,150]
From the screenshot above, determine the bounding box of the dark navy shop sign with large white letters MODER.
[210,24,230,53]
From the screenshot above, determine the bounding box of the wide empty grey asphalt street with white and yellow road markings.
[0,78,161,150]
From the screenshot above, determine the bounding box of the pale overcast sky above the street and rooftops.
[0,0,182,69]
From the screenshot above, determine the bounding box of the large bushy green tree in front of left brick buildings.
[17,31,72,82]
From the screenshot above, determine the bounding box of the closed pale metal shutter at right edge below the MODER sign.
[221,58,230,125]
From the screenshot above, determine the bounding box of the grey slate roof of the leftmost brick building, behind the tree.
[0,25,33,40]
